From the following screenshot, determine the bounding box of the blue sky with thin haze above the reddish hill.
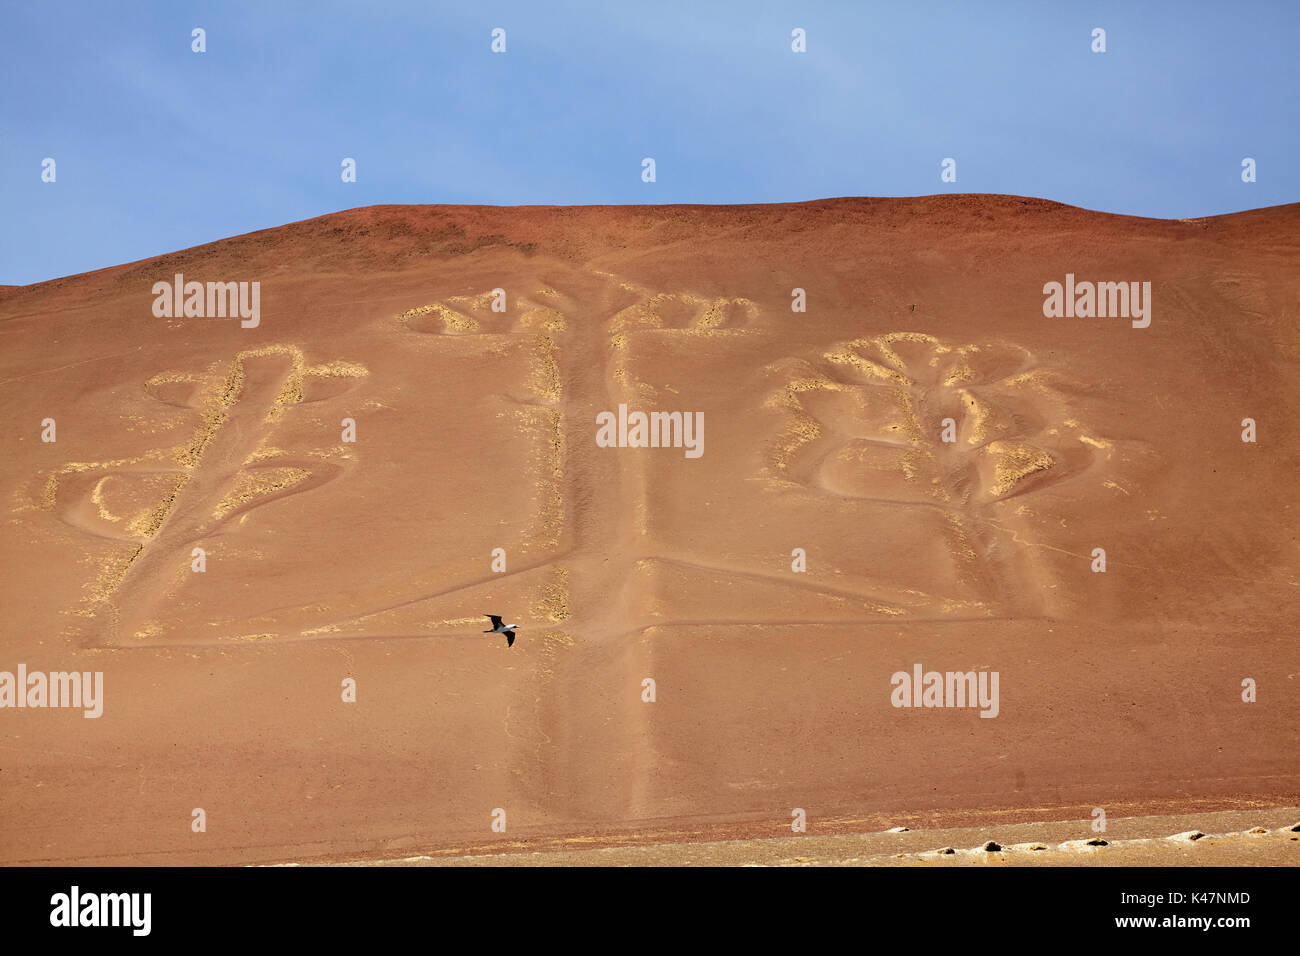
[0,0,1300,284]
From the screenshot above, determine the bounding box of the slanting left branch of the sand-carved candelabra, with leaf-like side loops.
[40,345,368,643]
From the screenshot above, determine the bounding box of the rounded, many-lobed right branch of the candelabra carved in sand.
[764,332,1133,615]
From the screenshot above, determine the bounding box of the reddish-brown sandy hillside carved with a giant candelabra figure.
[0,196,1300,862]
